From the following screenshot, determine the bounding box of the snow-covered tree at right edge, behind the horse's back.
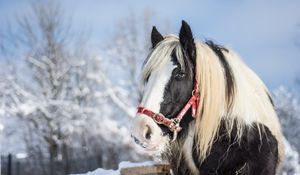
[273,86,300,175]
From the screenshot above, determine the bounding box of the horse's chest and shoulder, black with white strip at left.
[170,121,278,175]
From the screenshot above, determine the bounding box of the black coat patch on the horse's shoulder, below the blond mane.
[193,122,278,175]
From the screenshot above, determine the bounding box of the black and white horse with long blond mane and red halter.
[131,21,284,175]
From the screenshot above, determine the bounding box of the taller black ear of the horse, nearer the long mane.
[179,20,196,63]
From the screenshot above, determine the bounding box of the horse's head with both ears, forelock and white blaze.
[132,21,196,152]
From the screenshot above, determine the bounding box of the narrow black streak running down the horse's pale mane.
[206,41,235,111]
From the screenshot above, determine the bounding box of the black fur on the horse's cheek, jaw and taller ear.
[160,21,196,138]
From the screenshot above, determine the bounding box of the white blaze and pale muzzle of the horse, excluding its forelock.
[132,58,176,154]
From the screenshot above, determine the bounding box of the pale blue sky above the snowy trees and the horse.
[0,0,300,89]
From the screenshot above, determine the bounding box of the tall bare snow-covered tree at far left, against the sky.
[1,1,101,174]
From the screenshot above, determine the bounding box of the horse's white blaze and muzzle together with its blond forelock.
[132,36,185,154]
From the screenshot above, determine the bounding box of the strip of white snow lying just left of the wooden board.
[73,161,157,175]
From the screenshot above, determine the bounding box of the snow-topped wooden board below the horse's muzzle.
[121,164,171,175]
